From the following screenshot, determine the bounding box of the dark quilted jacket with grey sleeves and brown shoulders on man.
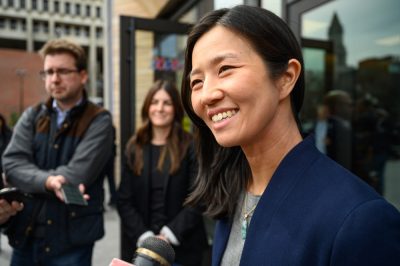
[3,96,112,256]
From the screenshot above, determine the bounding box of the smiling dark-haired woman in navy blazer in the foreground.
[182,6,400,266]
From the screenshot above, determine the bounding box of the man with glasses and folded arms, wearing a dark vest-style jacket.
[3,39,113,266]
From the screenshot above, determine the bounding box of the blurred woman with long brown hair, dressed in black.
[117,80,207,266]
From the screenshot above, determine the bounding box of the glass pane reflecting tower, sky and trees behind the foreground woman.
[301,0,400,208]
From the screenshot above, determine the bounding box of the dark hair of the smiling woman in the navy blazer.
[182,5,304,218]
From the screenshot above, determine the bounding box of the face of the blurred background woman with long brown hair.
[149,89,175,128]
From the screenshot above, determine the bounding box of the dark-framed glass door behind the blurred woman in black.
[120,16,190,153]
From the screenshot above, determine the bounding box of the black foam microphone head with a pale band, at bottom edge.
[133,237,175,266]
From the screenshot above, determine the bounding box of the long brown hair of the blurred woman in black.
[126,80,191,175]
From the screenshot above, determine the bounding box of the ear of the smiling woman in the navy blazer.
[278,59,301,100]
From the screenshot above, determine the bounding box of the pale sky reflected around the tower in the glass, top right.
[302,0,400,66]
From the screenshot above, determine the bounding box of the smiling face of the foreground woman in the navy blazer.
[190,26,279,147]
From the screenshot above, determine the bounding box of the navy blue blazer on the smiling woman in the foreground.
[212,138,400,266]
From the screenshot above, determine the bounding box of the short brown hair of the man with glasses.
[39,39,87,71]
